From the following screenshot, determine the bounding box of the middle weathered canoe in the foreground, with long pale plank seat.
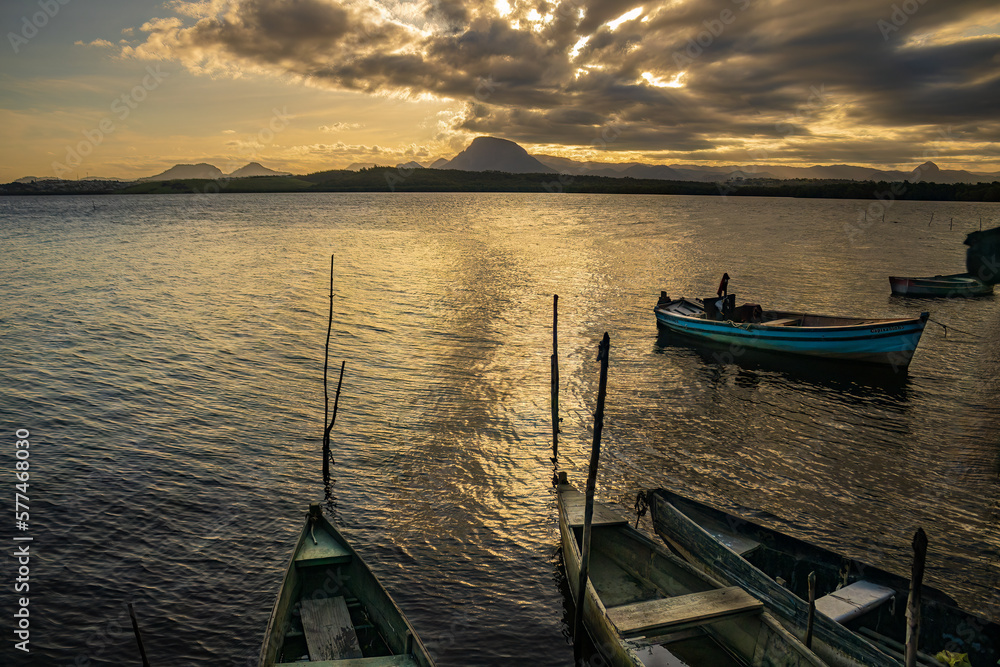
[558,478,826,667]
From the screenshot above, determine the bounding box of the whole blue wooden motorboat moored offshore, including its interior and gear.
[654,292,930,368]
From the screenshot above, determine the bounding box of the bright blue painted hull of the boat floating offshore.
[654,304,928,368]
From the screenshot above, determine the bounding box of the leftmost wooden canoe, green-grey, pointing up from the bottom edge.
[260,505,433,667]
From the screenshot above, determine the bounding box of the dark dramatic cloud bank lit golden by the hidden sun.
[122,0,1000,163]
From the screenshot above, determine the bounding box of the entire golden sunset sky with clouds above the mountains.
[0,0,1000,182]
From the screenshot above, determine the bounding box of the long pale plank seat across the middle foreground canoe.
[608,586,764,635]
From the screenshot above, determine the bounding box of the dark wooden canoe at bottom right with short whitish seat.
[647,489,1000,667]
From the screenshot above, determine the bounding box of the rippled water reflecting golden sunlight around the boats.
[0,194,1000,667]
